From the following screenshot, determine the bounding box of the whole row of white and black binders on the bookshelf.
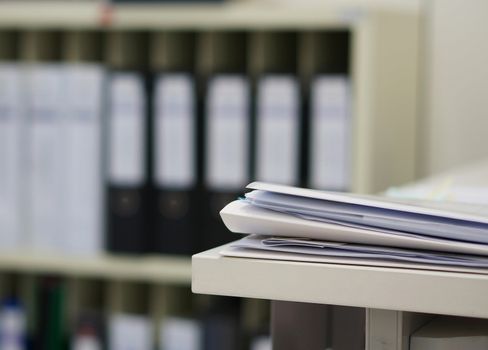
[0,30,352,254]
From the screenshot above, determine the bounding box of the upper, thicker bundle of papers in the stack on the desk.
[221,183,488,255]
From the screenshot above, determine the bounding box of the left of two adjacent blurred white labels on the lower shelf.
[108,313,153,350]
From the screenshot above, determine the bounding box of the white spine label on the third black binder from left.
[206,75,250,190]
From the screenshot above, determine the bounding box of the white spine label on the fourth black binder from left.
[256,75,300,185]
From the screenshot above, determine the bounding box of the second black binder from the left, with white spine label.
[151,73,199,255]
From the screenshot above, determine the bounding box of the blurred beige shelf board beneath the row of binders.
[0,251,191,285]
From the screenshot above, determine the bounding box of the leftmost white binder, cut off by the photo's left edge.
[0,63,26,250]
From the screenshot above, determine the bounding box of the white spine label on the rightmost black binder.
[310,76,351,190]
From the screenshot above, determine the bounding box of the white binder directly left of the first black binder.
[62,64,105,255]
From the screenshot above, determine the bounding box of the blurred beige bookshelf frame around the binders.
[0,0,421,348]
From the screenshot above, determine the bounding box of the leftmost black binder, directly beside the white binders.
[106,32,149,254]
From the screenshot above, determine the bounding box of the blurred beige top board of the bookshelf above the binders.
[0,0,419,30]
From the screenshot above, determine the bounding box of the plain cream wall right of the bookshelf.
[420,0,488,175]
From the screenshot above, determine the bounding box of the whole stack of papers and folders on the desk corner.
[221,182,488,273]
